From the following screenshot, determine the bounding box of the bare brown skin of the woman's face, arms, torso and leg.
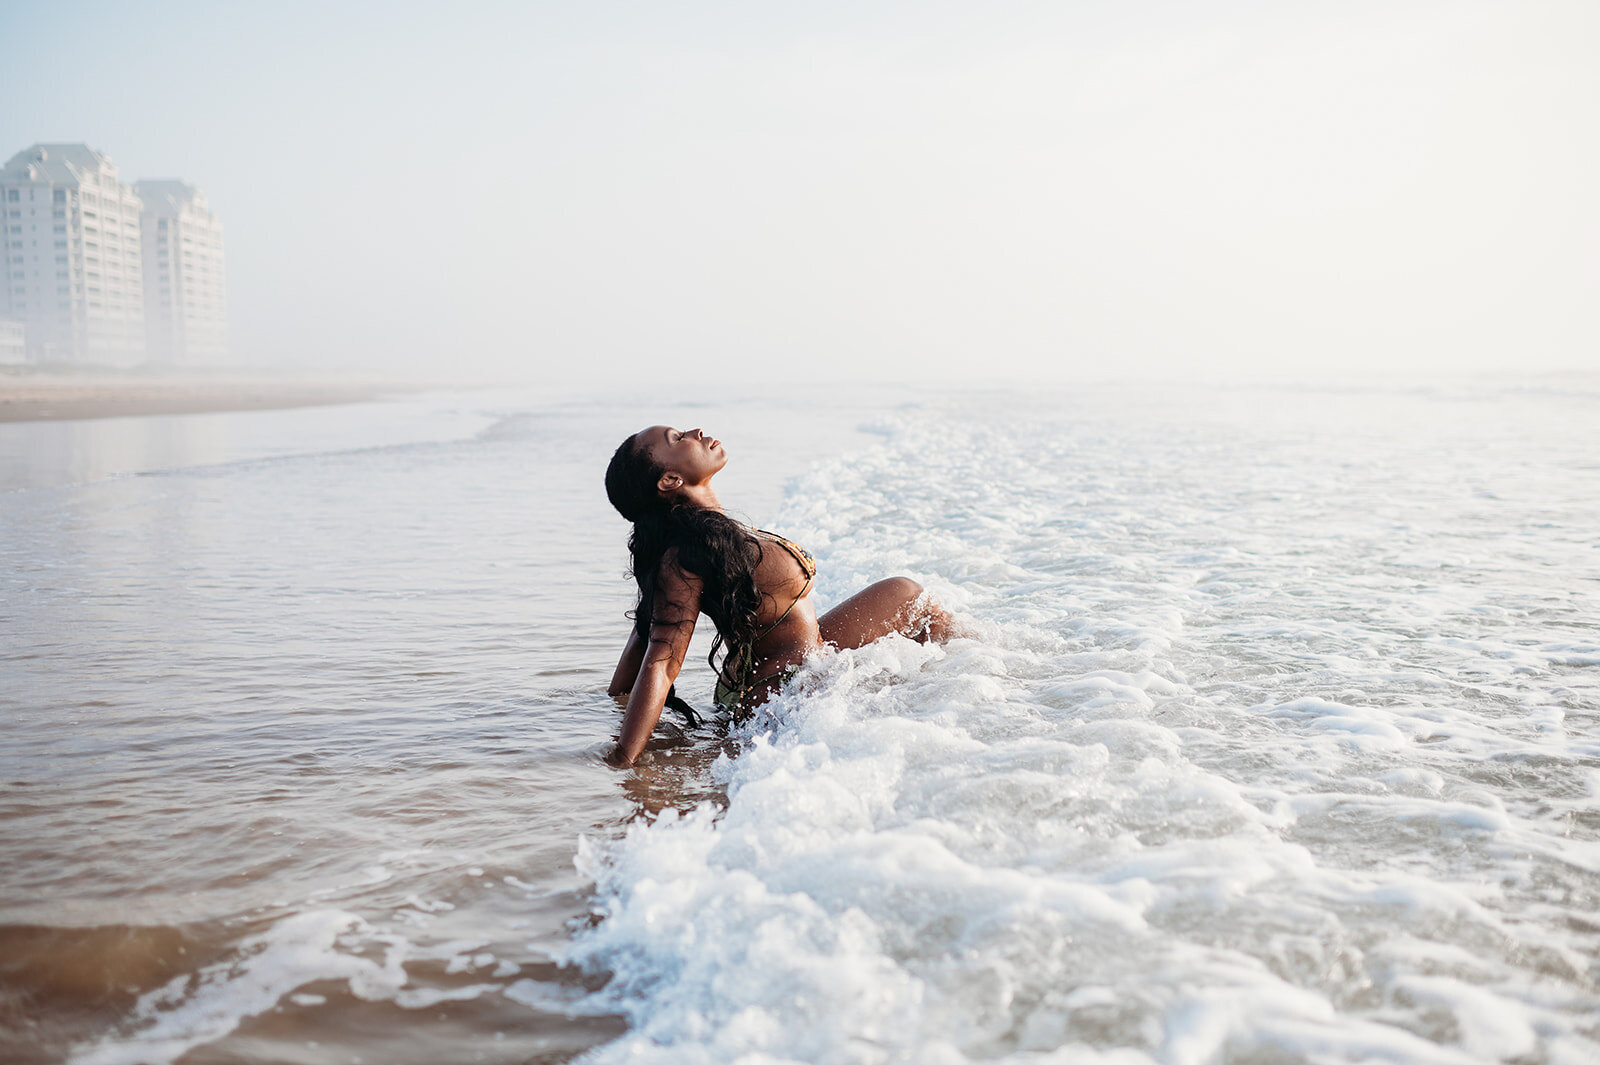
[606,425,957,766]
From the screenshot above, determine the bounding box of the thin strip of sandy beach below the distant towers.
[0,373,411,422]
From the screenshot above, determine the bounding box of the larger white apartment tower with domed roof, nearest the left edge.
[0,144,146,366]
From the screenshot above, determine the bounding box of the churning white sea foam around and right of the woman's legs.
[570,398,1600,1063]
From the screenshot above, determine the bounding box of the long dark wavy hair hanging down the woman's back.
[605,435,762,697]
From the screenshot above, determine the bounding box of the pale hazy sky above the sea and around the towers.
[0,0,1600,384]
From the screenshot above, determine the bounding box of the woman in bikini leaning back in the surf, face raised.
[605,425,954,766]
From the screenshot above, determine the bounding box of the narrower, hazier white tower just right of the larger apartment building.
[133,181,227,365]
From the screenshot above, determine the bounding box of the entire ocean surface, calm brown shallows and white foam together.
[0,381,1600,1065]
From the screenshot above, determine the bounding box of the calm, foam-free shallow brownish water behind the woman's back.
[0,383,877,1062]
